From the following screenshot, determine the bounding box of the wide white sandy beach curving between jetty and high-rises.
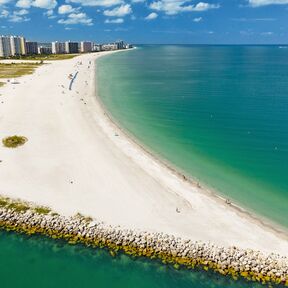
[0,52,288,255]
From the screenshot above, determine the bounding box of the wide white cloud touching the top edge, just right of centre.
[149,0,220,15]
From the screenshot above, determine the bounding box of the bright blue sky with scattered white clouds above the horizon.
[0,0,288,44]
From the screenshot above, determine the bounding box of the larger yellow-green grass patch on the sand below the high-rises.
[0,63,41,79]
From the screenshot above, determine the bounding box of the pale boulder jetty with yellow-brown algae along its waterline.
[0,197,288,286]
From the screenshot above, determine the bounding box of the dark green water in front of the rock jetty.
[0,230,270,288]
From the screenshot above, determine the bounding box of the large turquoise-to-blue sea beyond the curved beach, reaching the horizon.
[98,45,288,227]
